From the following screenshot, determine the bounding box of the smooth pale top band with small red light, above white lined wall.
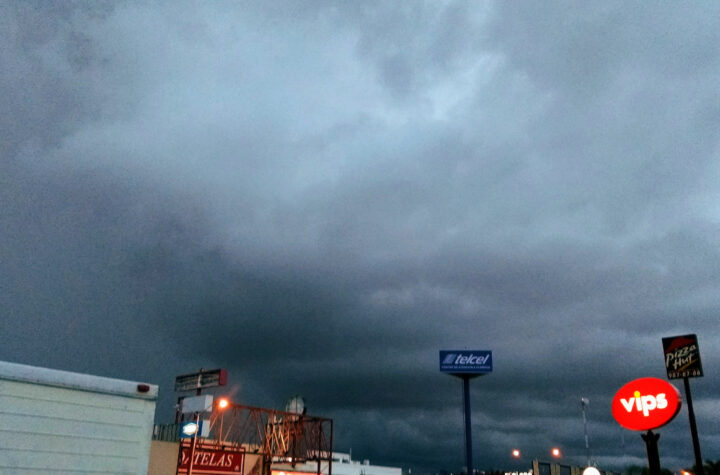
[0,361,158,400]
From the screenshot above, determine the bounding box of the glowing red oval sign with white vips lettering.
[612,378,682,430]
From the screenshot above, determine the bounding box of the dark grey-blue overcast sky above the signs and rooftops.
[0,0,720,473]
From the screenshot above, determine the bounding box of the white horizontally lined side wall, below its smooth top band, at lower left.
[0,375,155,474]
